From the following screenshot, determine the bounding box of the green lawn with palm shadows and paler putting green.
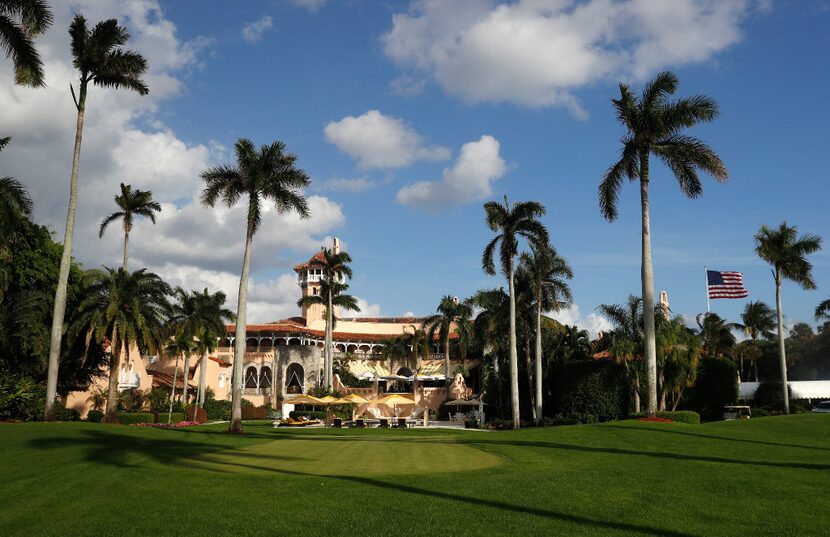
[0,415,830,537]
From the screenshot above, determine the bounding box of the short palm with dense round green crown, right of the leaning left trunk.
[71,268,171,421]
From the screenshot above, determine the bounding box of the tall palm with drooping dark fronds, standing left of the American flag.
[599,72,728,416]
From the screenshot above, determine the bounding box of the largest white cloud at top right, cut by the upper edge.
[382,0,763,117]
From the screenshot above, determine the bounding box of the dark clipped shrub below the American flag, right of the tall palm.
[685,358,738,421]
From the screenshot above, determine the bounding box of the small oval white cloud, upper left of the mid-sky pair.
[323,110,450,172]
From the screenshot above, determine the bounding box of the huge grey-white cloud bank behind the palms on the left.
[0,0,352,322]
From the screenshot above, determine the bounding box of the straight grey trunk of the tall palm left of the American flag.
[640,153,657,416]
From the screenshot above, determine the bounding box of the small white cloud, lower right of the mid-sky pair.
[397,135,507,210]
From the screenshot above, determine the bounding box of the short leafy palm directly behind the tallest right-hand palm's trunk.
[597,295,657,414]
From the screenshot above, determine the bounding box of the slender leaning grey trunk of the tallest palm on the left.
[45,83,86,421]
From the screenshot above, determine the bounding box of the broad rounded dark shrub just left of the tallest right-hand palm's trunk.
[554,361,630,423]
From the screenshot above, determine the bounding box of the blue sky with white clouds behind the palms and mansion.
[4,0,830,329]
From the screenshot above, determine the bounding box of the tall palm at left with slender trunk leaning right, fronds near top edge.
[45,15,149,421]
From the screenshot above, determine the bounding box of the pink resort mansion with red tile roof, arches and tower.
[67,238,479,415]
